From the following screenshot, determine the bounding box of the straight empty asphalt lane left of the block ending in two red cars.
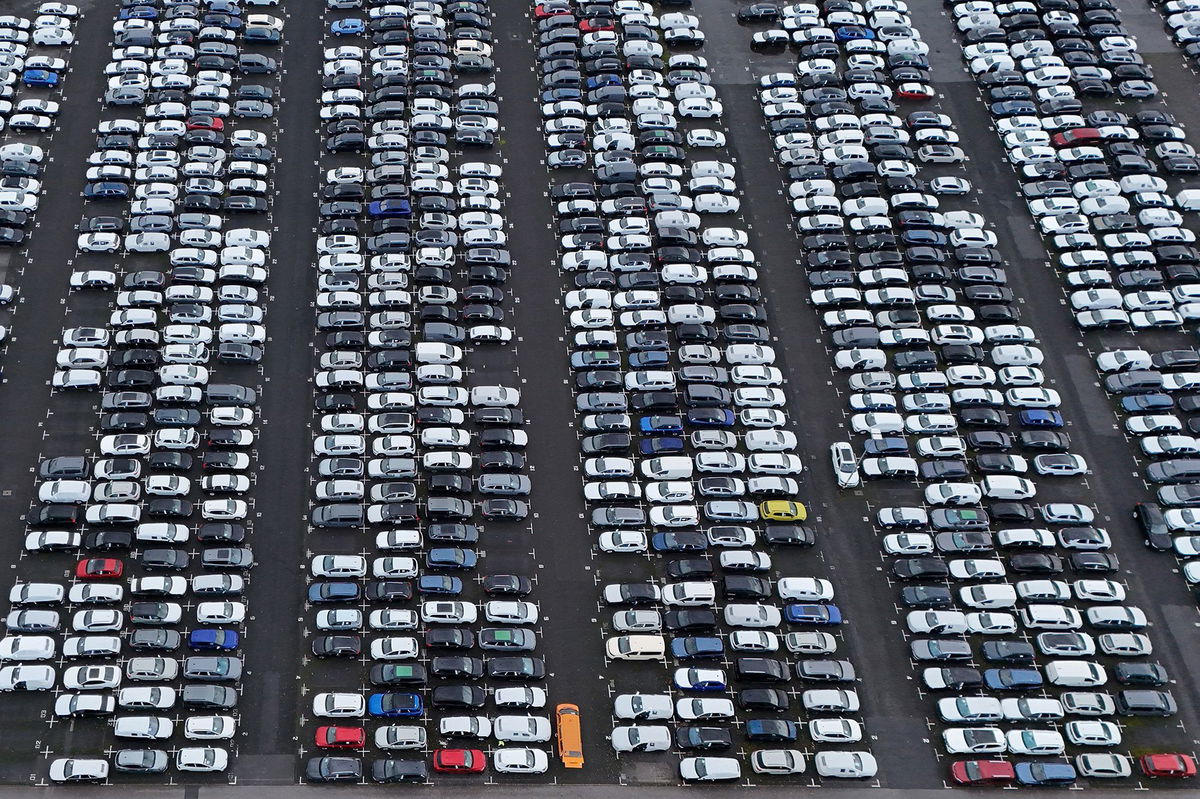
[235,4,323,783]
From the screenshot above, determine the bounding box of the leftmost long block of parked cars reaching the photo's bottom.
[22,0,282,781]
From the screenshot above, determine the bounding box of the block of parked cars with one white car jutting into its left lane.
[744,0,1195,783]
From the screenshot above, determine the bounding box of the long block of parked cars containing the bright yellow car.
[534,0,876,781]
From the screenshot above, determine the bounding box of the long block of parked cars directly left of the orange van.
[305,0,551,782]
